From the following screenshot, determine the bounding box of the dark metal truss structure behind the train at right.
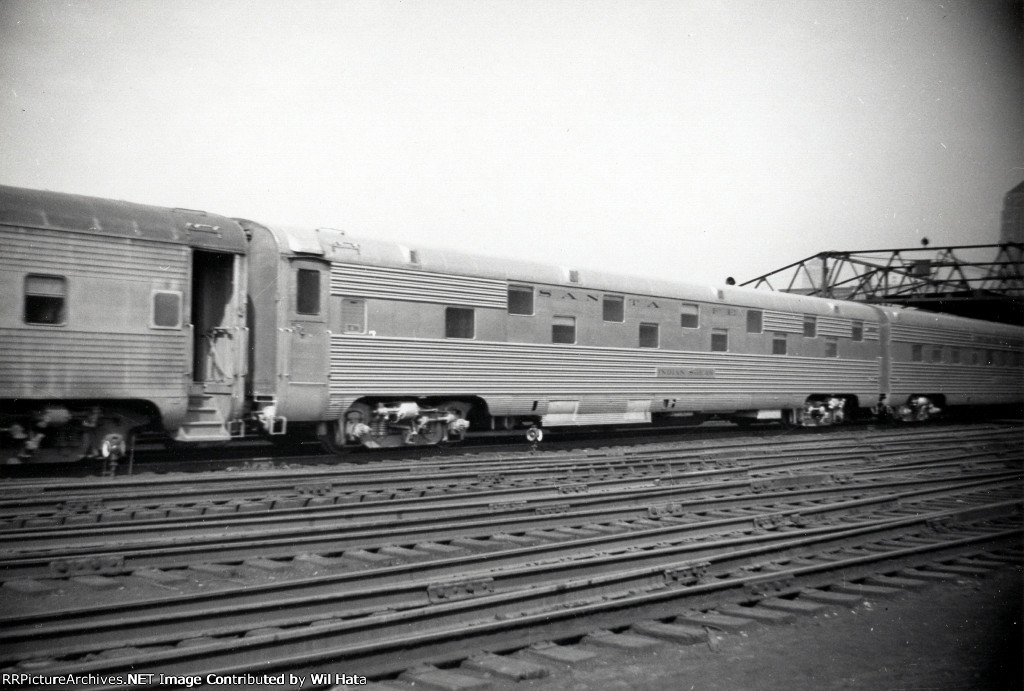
[741,243,1024,325]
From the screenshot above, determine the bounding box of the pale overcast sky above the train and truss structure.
[0,0,1024,283]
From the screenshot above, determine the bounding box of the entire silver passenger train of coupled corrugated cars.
[0,187,1024,460]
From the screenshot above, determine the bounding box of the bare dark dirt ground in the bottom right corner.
[496,567,1024,691]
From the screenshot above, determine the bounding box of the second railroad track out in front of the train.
[0,440,1019,579]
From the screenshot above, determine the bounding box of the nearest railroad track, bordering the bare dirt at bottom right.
[4,502,1021,687]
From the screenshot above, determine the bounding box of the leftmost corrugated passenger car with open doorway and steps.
[0,186,247,460]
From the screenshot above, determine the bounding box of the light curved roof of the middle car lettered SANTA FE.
[265,225,879,320]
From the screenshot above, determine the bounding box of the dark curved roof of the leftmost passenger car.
[0,185,247,254]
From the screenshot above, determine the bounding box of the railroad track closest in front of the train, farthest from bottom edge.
[0,426,1019,529]
